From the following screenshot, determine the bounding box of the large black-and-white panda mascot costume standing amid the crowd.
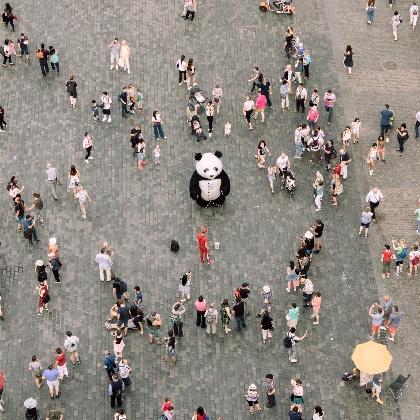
[190,151,230,207]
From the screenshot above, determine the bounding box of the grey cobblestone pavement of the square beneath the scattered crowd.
[0,0,418,420]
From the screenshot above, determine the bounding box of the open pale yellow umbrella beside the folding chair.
[351,341,392,375]
